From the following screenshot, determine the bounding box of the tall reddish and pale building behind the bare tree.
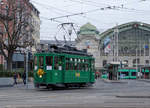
[0,0,40,69]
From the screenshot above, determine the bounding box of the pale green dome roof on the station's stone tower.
[78,22,99,35]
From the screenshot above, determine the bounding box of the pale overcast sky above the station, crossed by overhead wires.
[31,0,150,40]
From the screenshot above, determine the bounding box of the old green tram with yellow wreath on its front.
[34,45,95,88]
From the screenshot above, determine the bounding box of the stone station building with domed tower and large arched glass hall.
[76,22,150,70]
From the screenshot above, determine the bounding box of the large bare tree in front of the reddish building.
[0,0,34,70]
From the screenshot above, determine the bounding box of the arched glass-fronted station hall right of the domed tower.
[99,22,150,67]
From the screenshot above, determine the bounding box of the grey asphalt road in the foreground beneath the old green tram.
[0,79,150,108]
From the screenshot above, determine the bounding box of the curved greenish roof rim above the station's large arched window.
[99,22,150,40]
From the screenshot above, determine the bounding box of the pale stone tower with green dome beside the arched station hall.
[76,23,100,70]
